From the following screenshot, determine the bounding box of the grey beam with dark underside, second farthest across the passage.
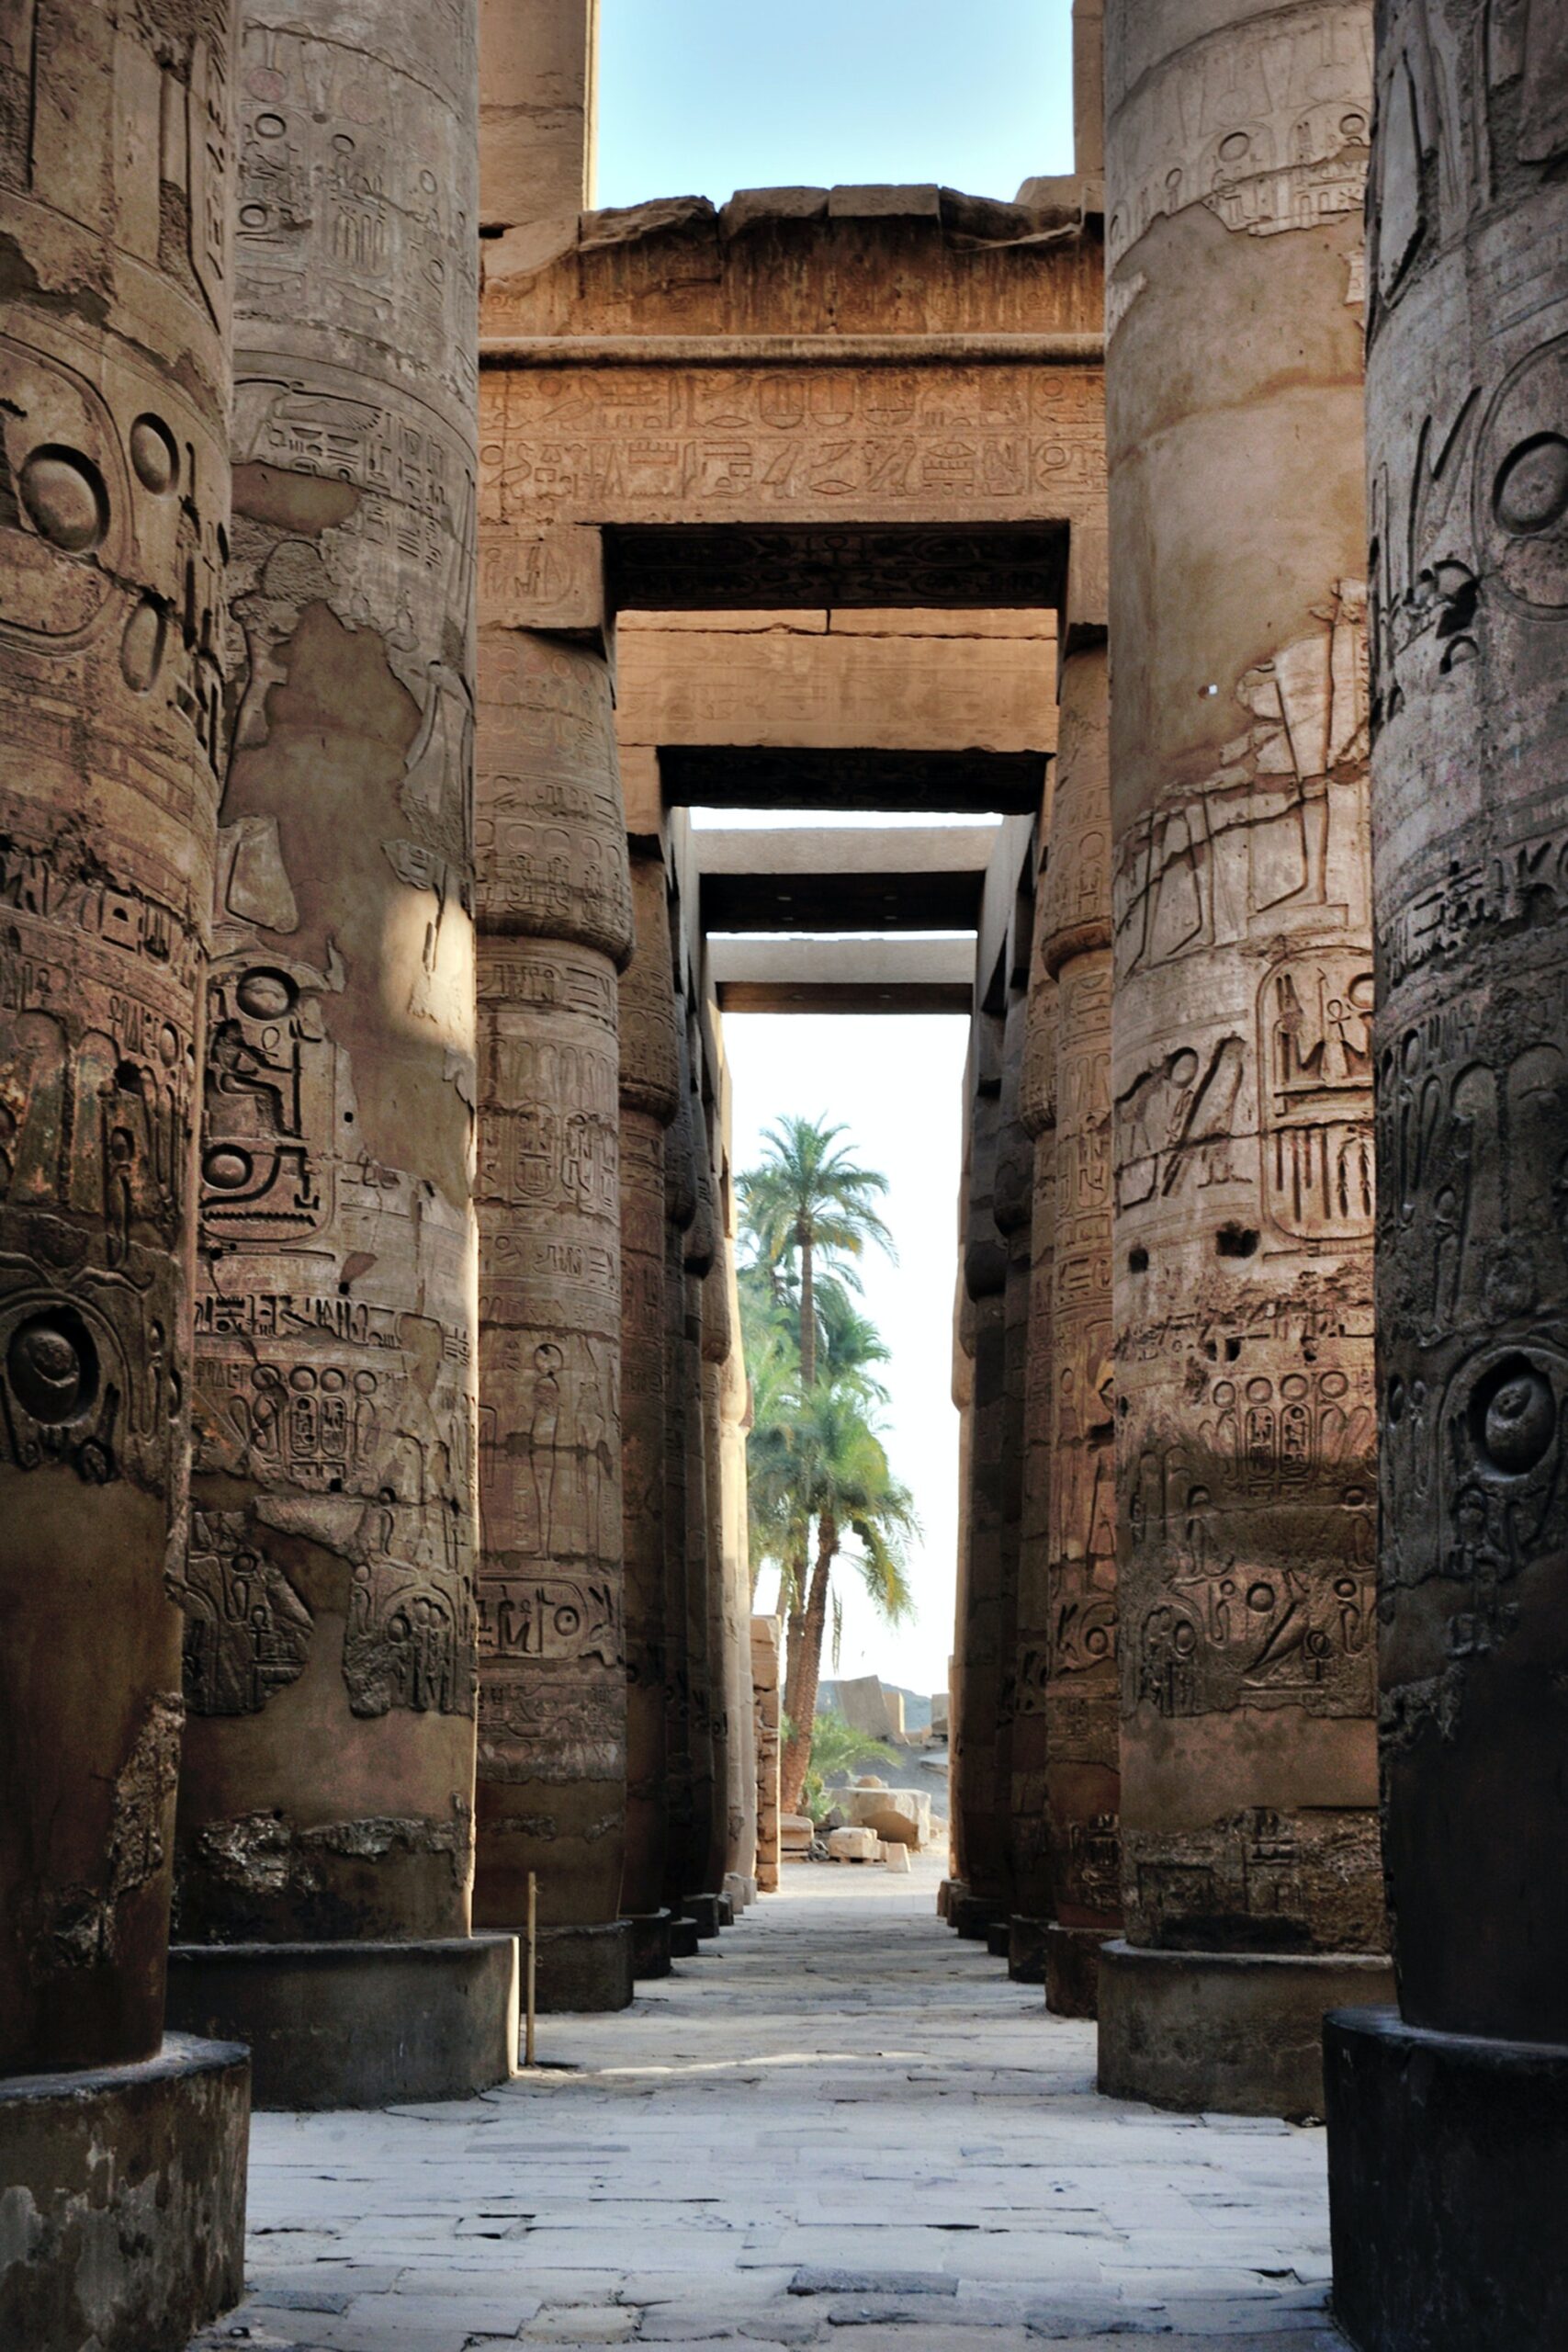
[694,826,997,932]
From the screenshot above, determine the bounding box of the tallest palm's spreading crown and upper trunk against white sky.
[740,1117,898,1390]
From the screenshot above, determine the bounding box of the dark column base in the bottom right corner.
[1324,2008,1568,2352]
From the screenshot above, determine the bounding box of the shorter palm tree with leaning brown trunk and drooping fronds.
[781,1381,919,1814]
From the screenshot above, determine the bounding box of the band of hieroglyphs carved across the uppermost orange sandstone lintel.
[479,365,1102,525]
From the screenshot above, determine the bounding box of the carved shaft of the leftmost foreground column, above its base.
[0,0,235,2072]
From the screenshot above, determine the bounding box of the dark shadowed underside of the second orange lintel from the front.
[659,762,1046,816]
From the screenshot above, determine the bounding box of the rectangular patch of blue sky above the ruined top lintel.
[594,0,1072,205]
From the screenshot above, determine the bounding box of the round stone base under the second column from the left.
[167,1936,520,2108]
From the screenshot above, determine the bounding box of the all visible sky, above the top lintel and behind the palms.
[594,18,1072,1691]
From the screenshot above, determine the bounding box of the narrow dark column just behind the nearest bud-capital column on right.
[1010,889,1055,1983]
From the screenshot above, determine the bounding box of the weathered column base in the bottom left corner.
[0,2034,249,2352]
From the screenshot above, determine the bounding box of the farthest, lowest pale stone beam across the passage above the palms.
[707,938,976,1013]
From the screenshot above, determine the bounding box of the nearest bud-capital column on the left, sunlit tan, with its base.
[475,628,632,2008]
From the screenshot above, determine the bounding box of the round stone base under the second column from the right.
[1100,1938,1394,2120]
